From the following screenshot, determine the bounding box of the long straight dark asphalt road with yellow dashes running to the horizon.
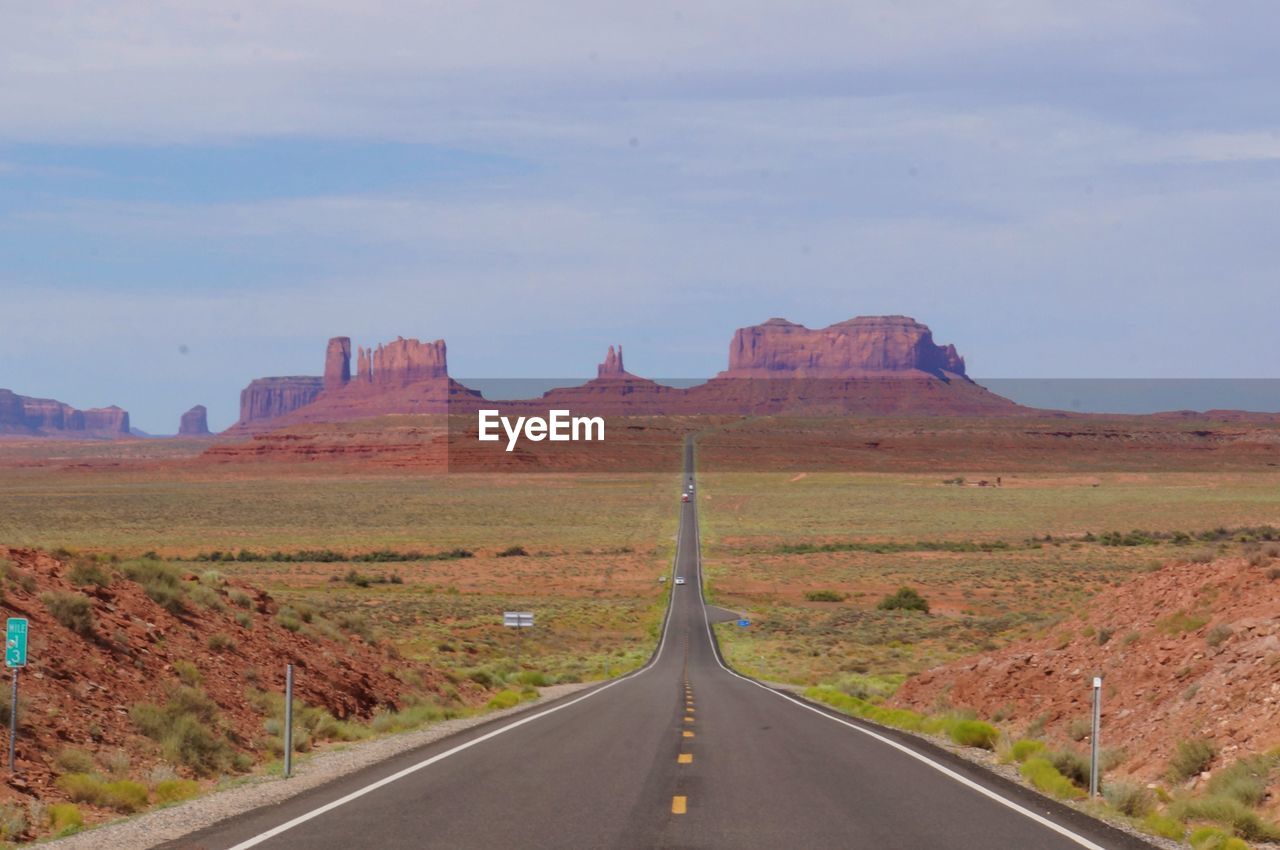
[165,452,1149,850]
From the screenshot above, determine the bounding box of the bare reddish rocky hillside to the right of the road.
[895,544,1280,780]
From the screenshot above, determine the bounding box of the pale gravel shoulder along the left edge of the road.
[40,682,596,850]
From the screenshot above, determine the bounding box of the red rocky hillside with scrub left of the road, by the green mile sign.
[0,547,484,838]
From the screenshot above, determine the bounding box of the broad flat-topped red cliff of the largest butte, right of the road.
[721,316,964,378]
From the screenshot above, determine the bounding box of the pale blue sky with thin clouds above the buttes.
[0,0,1280,433]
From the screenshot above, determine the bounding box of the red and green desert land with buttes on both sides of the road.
[0,317,1280,846]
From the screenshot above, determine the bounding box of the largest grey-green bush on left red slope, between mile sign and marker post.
[129,685,237,776]
